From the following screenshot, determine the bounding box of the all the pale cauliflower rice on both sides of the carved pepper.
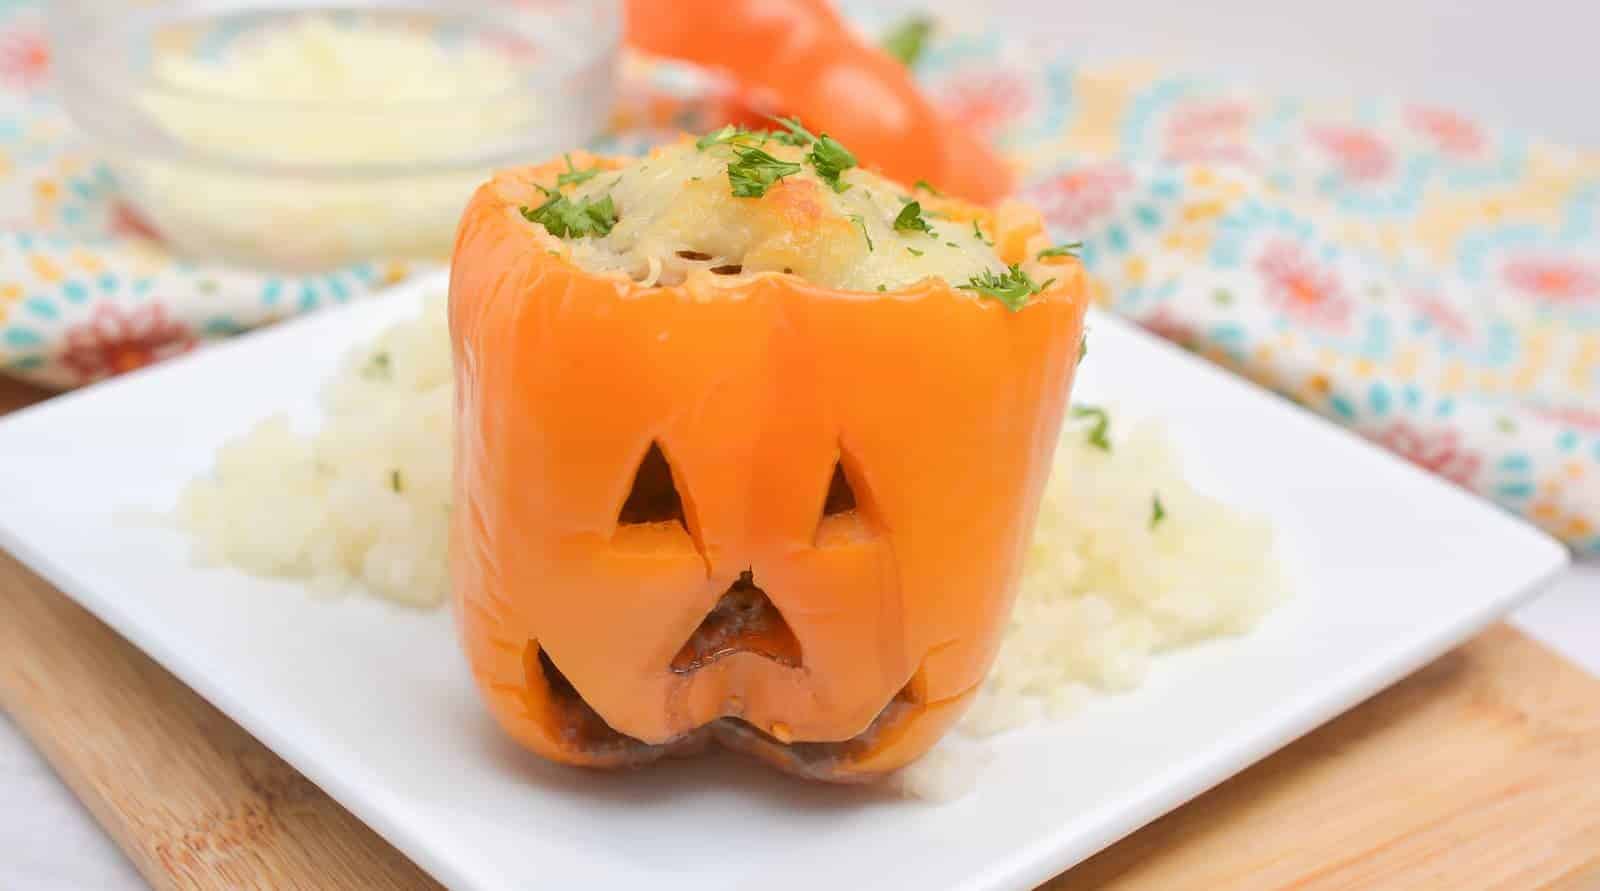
[179,298,1286,774]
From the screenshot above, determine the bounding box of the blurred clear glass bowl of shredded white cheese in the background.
[50,0,621,272]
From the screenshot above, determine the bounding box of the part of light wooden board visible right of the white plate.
[1046,625,1600,891]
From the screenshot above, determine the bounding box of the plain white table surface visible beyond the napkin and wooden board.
[0,0,1600,891]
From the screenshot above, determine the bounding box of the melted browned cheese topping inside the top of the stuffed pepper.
[553,141,1006,291]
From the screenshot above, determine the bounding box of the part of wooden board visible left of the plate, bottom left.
[0,552,437,889]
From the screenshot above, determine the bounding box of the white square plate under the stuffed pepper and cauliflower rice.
[0,270,1566,891]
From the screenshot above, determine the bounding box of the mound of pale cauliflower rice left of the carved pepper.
[178,298,451,606]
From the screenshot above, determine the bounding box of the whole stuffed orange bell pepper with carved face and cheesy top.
[450,125,1086,781]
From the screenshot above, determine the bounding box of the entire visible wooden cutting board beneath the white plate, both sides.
[0,379,1600,891]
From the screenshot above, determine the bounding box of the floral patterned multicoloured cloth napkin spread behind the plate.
[0,0,1600,555]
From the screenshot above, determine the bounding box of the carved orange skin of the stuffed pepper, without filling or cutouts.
[450,152,1086,782]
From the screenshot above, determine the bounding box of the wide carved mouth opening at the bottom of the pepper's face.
[528,643,917,779]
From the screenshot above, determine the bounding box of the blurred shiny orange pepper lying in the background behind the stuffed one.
[626,0,1013,205]
